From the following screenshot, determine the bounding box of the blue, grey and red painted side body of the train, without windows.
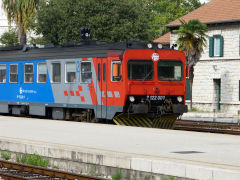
[0,57,123,119]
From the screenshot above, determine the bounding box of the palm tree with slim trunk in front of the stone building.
[173,19,207,109]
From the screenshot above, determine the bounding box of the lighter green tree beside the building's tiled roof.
[151,0,201,38]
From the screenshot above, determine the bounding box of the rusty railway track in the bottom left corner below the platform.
[0,160,106,180]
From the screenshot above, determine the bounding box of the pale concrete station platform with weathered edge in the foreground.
[0,116,240,180]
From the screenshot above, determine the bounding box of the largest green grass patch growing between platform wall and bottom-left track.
[16,154,49,168]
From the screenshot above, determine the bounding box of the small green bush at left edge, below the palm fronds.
[0,29,18,46]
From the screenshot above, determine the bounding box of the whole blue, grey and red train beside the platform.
[0,40,188,128]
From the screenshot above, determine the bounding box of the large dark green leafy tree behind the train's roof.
[36,0,152,44]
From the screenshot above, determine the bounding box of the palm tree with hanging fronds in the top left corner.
[2,0,38,45]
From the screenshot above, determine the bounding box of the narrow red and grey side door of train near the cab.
[96,58,107,119]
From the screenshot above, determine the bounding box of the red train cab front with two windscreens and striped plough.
[112,49,187,128]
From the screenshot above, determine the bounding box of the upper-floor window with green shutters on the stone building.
[209,35,224,57]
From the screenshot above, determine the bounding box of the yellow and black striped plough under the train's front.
[113,114,178,129]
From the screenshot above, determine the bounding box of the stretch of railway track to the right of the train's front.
[174,120,240,135]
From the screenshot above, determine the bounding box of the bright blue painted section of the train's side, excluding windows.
[0,60,54,103]
